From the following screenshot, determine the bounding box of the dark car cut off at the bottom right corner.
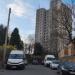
[58,62,75,75]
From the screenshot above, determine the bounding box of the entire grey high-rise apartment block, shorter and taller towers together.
[35,0,71,55]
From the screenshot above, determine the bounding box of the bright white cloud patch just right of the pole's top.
[7,1,25,16]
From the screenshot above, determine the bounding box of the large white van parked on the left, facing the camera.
[6,50,27,69]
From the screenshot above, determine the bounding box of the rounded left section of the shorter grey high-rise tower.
[35,8,46,45]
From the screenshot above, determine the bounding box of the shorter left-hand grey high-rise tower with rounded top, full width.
[35,8,50,51]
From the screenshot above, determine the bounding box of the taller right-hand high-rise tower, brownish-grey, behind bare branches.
[50,0,72,55]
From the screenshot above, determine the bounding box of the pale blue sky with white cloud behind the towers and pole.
[0,0,74,40]
